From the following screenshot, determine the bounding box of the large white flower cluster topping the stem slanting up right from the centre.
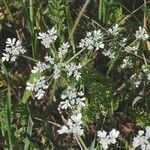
[79,30,104,50]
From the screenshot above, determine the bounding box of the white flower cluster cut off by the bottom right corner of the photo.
[132,126,150,150]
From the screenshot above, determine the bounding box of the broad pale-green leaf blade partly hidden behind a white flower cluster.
[21,72,41,104]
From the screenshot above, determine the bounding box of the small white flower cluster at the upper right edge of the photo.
[135,26,149,40]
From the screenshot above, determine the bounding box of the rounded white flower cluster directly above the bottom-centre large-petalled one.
[59,86,86,110]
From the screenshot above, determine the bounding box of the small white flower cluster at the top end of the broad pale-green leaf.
[31,62,50,73]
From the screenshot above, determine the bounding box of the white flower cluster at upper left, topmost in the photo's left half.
[37,27,57,48]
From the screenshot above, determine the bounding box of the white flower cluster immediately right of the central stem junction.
[65,62,82,81]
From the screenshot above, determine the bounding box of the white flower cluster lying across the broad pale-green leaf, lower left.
[26,76,48,99]
